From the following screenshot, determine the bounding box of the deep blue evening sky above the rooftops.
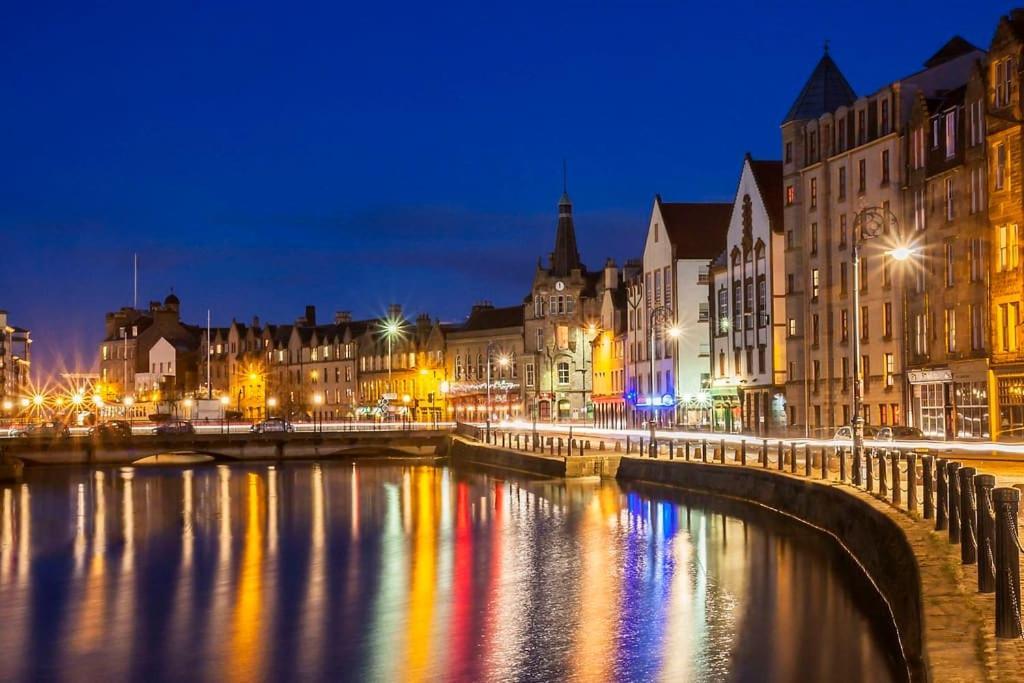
[0,0,1009,373]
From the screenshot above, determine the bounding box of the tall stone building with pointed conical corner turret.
[781,41,981,434]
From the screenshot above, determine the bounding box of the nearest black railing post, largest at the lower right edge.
[992,487,1021,638]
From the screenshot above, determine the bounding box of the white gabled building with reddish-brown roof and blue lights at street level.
[627,197,732,425]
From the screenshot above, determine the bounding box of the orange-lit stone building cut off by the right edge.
[985,9,1024,440]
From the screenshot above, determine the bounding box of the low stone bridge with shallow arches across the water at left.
[0,429,449,465]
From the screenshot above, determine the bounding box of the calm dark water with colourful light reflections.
[0,463,899,681]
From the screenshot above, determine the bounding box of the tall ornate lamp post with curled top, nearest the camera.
[850,207,913,485]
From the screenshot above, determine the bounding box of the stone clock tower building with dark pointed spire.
[522,191,604,421]
